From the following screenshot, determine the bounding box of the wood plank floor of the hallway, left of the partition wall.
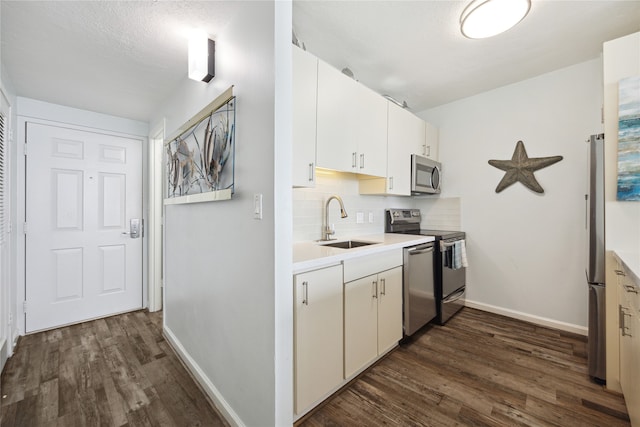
[0,311,228,427]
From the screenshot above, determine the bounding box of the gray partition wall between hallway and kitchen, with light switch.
[151,1,292,426]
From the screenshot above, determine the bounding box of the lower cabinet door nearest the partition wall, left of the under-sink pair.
[294,266,343,414]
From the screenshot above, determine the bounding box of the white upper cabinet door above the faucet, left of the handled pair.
[316,60,358,172]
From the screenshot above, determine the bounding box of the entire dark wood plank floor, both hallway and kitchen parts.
[0,308,630,427]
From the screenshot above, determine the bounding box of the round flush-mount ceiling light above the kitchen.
[460,0,531,39]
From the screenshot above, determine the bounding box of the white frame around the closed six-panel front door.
[14,112,149,335]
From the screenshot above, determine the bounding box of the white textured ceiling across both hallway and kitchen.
[0,0,640,121]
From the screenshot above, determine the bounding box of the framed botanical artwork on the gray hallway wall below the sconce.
[164,87,236,205]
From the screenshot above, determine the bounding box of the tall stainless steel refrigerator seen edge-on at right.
[585,134,606,384]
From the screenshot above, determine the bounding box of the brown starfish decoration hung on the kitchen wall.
[489,141,562,193]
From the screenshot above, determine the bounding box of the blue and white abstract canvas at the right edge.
[617,76,640,201]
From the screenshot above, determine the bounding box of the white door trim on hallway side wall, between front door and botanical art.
[146,120,165,311]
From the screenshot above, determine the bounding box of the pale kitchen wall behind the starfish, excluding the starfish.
[421,59,603,333]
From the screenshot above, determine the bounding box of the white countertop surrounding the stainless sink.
[293,233,434,274]
